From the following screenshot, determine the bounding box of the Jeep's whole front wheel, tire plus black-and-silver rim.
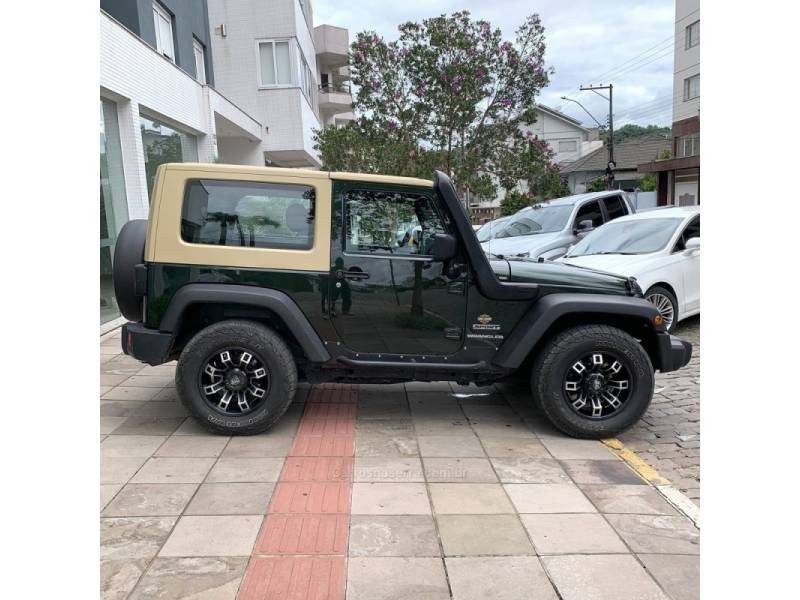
[531,325,655,439]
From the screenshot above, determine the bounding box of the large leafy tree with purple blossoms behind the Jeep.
[316,11,555,198]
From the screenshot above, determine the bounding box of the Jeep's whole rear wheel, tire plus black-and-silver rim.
[175,320,297,435]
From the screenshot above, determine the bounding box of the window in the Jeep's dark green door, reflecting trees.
[344,190,444,256]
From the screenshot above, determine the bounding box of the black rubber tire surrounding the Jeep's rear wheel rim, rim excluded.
[175,320,297,435]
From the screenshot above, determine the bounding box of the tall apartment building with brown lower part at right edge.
[639,0,700,206]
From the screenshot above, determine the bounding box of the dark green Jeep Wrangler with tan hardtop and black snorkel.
[114,164,692,438]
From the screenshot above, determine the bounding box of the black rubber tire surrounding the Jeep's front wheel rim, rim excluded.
[531,325,655,439]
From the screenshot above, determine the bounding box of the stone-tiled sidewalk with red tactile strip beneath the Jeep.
[100,334,699,600]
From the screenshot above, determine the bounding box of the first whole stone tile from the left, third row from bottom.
[102,483,197,517]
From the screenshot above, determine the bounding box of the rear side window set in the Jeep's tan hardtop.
[181,179,314,250]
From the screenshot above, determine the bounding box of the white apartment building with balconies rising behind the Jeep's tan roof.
[208,0,352,168]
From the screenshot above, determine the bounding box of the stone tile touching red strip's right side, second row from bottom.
[349,515,440,556]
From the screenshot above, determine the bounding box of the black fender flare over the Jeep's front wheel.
[492,294,666,369]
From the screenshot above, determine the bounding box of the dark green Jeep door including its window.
[323,181,467,355]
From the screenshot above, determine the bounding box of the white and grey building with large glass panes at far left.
[99,0,264,328]
